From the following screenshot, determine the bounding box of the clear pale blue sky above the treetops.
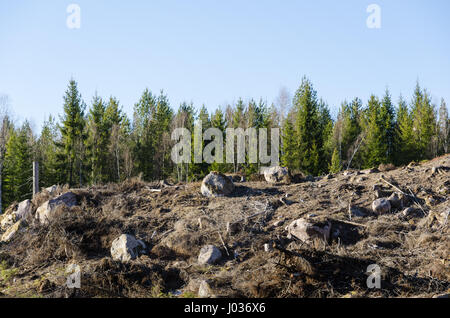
[0,0,450,130]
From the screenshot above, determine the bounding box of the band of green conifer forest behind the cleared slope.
[0,77,450,208]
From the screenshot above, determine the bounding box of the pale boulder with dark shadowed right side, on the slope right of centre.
[286,218,331,242]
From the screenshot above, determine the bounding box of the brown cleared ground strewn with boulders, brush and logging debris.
[0,155,450,297]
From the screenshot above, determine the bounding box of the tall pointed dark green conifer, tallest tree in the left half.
[58,79,87,186]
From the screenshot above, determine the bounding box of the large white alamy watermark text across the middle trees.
[171,121,280,166]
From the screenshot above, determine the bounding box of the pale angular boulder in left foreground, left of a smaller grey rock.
[111,234,146,262]
